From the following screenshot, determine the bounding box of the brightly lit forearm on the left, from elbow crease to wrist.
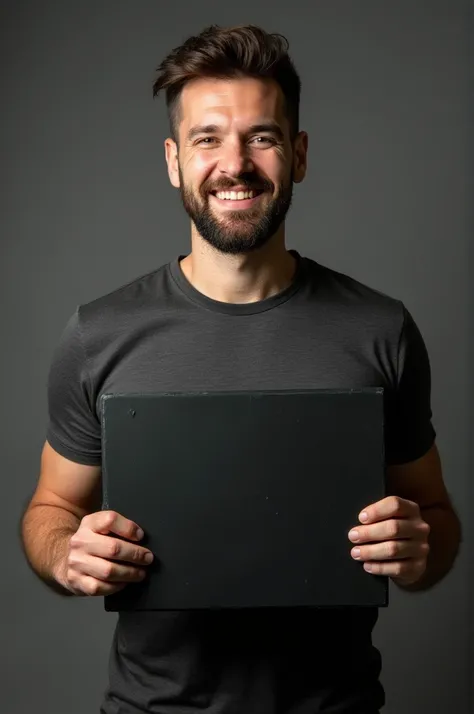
[21,504,80,595]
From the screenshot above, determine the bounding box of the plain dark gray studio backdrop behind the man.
[0,0,474,714]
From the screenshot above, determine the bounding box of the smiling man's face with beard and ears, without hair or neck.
[166,78,308,255]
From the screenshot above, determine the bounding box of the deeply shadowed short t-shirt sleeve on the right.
[385,306,436,464]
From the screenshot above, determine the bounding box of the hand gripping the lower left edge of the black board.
[56,511,153,595]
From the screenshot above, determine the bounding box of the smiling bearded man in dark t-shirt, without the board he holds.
[22,26,460,714]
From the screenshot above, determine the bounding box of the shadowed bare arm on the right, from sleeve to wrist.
[386,444,462,591]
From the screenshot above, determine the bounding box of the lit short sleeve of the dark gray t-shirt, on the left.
[46,307,101,466]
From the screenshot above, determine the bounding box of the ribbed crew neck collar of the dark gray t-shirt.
[168,250,305,315]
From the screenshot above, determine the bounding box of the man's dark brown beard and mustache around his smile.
[179,167,293,255]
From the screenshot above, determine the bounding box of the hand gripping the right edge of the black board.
[349,496,430,585]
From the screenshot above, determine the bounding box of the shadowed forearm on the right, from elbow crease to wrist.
[395,506,462,592]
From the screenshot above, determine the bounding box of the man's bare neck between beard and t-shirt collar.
[180,232,296,304]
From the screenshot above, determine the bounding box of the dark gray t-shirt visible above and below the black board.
[47,251,435,714]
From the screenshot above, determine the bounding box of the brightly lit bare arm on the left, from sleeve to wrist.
[20,442,101,595]
